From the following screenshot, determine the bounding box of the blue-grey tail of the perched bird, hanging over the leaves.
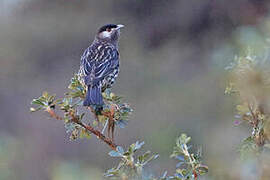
[83,86,104,106]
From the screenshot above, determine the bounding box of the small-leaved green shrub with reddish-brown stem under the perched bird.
[30,74,208,180]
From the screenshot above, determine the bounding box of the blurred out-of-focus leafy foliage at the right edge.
[225,49,270,158]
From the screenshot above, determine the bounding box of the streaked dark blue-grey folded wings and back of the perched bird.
[81,47,119,85]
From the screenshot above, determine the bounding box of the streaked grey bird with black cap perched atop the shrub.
[78,24,124,109]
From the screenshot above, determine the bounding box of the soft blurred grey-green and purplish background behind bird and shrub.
[0,0,270,180]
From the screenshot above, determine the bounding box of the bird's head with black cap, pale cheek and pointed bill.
[96,24,124,44]
